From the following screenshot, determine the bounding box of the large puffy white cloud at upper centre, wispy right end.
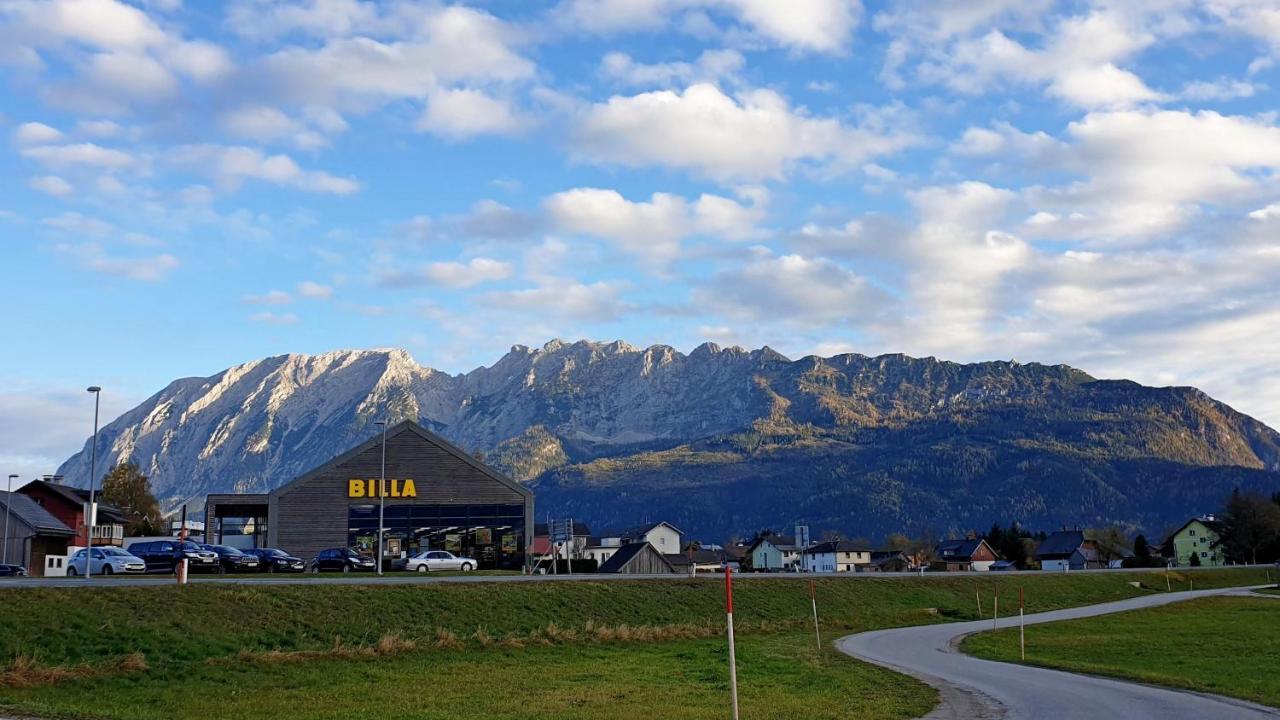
[571,85,914,181]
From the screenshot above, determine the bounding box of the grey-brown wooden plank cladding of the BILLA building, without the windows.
[206,420,534,560]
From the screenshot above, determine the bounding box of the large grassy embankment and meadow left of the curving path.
[0,570,1261,720]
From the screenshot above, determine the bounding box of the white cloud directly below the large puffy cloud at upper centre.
[543,187,764,264]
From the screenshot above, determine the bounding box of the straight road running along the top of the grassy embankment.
[0,565,1272,589]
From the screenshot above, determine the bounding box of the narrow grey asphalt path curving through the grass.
[836,588,1280,720]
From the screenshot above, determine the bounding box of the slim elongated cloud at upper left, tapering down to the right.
[170,145,360,195]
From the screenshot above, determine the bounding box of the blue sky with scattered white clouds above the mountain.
[0,0,1280,474]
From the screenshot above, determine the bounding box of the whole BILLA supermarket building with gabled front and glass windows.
[205,420,534,570]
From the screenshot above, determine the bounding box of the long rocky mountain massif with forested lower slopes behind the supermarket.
[59,341,1280,538]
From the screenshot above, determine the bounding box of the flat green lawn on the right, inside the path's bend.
[961,591,1280,707]
